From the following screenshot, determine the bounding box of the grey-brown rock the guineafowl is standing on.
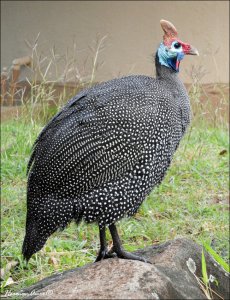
[22,239,229,299]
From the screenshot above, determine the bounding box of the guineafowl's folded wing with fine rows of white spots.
[29,83,172,198]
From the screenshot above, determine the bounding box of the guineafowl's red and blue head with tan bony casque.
[157,20,199,72]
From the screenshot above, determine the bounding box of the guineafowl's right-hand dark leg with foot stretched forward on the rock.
[109,224,150,263]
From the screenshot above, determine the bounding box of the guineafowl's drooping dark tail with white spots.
[22,199,81,262]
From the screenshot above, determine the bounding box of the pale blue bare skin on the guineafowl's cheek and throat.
[158,43,184,72]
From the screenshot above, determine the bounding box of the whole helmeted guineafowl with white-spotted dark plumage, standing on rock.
[22,20,198,261]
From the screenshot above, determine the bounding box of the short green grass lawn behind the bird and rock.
[1,113,229,293]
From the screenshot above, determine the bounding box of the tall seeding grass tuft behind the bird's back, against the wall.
[18,34,106,124]
